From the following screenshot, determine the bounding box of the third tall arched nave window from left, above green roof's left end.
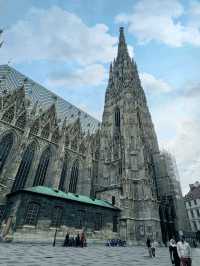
[33,147,51,186]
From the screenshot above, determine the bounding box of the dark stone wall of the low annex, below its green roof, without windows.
[5,191,119,242]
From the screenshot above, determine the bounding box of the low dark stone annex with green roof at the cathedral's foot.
[2,187,120,243]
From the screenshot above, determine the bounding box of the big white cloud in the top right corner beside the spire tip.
[115,0,200,47]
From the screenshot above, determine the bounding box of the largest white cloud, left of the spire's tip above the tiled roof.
[0,6,117,65]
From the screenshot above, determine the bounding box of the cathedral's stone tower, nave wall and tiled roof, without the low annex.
[0,28,188,243]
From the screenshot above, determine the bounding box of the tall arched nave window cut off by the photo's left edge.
[0,133,14,173]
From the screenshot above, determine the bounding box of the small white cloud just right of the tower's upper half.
[140,73,173,93]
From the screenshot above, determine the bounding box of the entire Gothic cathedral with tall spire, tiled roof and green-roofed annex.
[0,27,188,243]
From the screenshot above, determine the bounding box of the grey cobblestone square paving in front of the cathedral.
[0,244,200,266]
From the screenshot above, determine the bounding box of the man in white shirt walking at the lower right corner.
[177,236,192,266]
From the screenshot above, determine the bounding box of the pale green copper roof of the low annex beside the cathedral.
[23,186,119,210]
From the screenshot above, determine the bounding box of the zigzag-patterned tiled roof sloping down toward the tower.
[0,65,100,133]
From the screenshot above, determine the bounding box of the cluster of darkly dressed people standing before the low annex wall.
[63,232,87,248]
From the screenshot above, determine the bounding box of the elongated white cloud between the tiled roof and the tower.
[46,64,107,88]
